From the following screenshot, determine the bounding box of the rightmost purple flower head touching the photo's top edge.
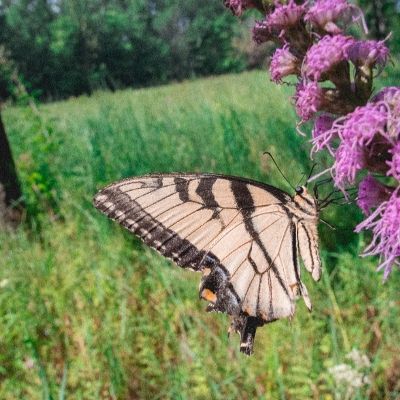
[304,0,362,34]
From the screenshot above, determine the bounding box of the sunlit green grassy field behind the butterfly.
[0,72,400,400]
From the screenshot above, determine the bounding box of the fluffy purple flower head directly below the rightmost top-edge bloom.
[303,34,354,81]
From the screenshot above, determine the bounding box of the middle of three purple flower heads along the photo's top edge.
[267,0,305,34]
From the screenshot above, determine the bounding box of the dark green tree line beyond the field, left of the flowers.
[0,0,243,100]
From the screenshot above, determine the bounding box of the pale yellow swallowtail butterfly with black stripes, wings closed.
[94,174,321,354]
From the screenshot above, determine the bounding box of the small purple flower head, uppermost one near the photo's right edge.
[347,40,389,67]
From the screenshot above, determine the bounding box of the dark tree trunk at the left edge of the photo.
[0,109,23,227]
